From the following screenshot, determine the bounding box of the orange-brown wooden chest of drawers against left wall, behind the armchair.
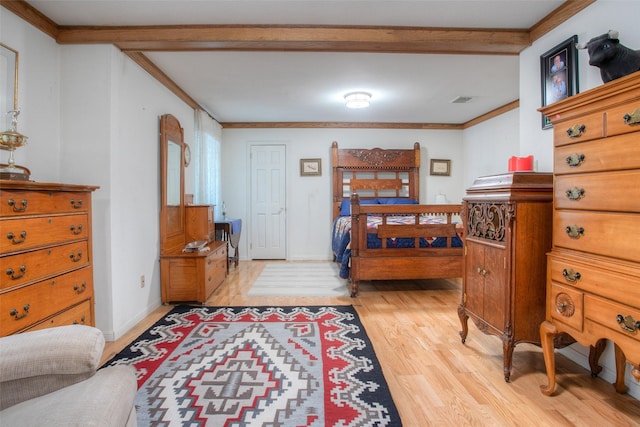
[0,180,98,336]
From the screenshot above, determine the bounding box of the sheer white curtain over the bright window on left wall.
[193,110,222,218]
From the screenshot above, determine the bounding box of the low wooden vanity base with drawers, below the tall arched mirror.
[160,205,228,304]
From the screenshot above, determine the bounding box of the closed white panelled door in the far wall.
[249,145,287,259]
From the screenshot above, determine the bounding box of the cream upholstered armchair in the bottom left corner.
[0,325,137,427]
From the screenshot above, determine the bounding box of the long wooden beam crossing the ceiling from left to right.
[56,25,530,55]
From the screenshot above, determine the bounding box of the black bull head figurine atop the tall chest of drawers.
[576,30,640,83]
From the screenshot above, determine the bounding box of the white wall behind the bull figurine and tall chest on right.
[519,0,640,399]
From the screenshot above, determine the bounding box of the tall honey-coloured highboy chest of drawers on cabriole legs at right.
[540,72,640,395]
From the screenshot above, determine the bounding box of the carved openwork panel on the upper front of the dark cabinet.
[466,202,513,242]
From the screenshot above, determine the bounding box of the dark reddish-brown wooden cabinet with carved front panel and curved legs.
[458,172,553,382]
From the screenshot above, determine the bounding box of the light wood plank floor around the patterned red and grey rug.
[103,261,640,427]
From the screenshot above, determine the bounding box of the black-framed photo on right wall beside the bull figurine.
[540,35,578,129]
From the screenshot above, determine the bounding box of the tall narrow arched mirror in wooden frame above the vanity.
[160,114,185,253]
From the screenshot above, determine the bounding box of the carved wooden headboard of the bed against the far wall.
[331,141,420,218]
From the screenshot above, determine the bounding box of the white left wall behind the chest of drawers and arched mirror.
[0,8,194,340]
